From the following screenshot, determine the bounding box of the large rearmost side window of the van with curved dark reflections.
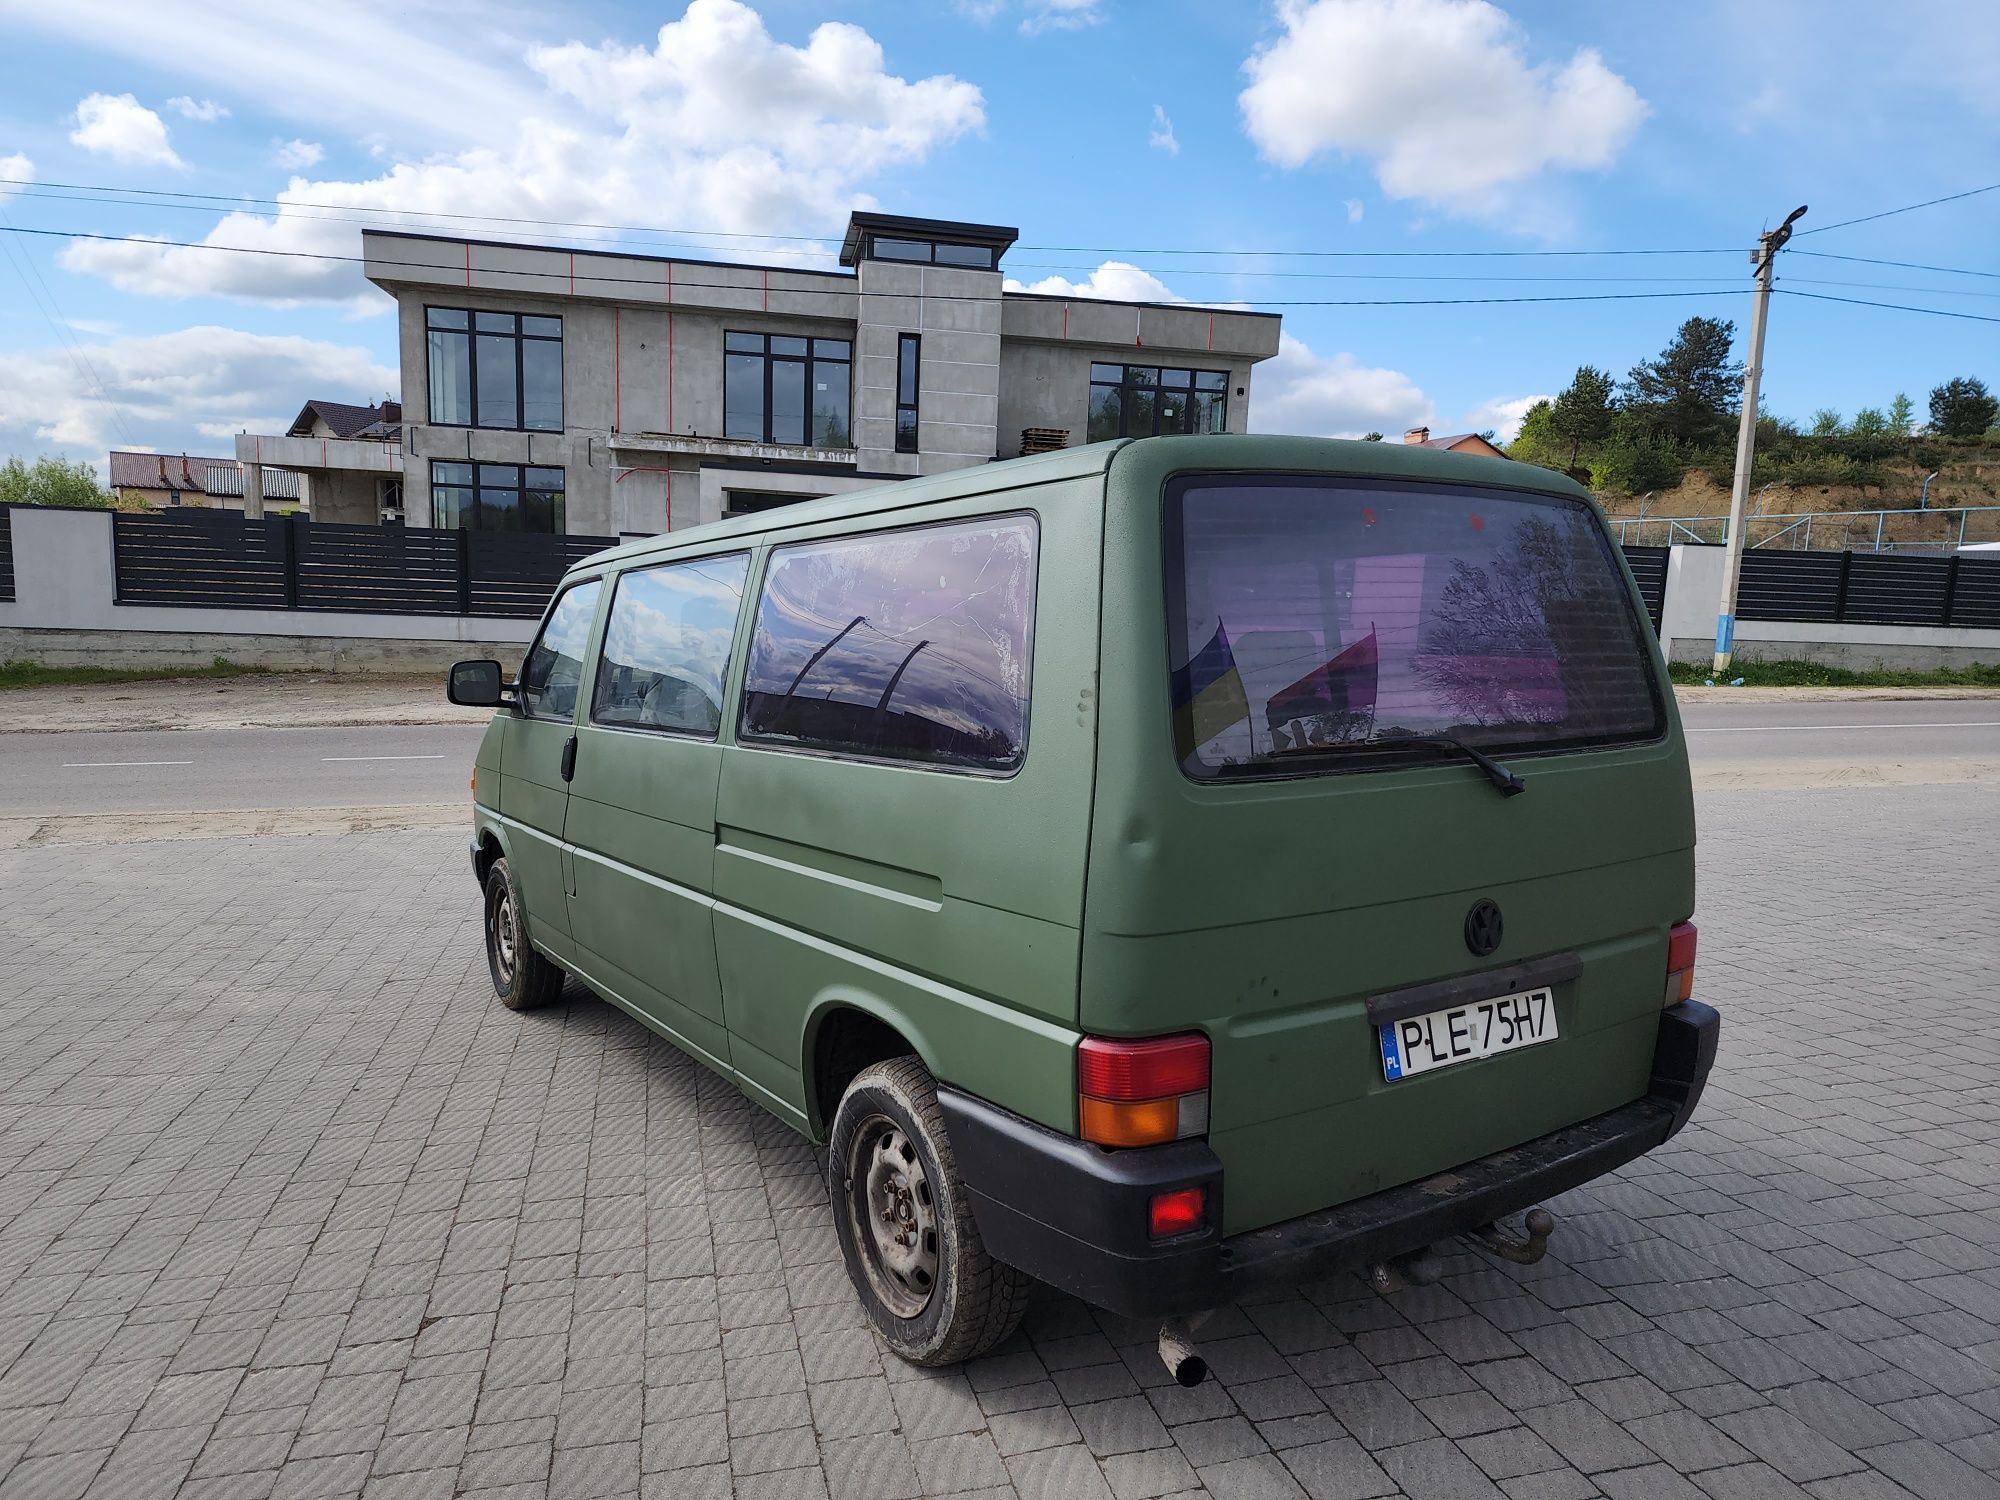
[738,516,1036,770]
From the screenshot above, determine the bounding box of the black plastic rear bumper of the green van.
[938,1000,1722,1316]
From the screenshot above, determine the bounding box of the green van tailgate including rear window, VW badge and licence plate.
[1082,456,1694,1232]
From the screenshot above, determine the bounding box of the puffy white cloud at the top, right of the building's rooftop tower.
[1238,0,1648,218]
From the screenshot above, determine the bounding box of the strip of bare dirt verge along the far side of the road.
[0,672,2000,734]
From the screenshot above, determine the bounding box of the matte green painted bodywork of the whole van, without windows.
[464,436,1694,1232]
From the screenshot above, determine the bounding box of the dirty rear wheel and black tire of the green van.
[828,1056,1032,1364]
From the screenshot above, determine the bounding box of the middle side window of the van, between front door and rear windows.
[590,552,750,740]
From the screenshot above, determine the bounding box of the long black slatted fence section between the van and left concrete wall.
[112,510,618,618]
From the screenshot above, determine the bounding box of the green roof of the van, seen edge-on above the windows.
[574,432,1590,572]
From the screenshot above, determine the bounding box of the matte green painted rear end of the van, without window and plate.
[1080,436,1694,1232]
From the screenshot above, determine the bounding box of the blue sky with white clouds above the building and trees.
[0,0,2000,464]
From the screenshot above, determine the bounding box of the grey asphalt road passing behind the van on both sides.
[0,698,2000,816]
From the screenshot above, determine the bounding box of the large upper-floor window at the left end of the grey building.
[424,308,562,432]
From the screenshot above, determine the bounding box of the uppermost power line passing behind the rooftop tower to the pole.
[0,178,1742,260]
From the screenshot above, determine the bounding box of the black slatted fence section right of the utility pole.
[1736,550,2000,630]
